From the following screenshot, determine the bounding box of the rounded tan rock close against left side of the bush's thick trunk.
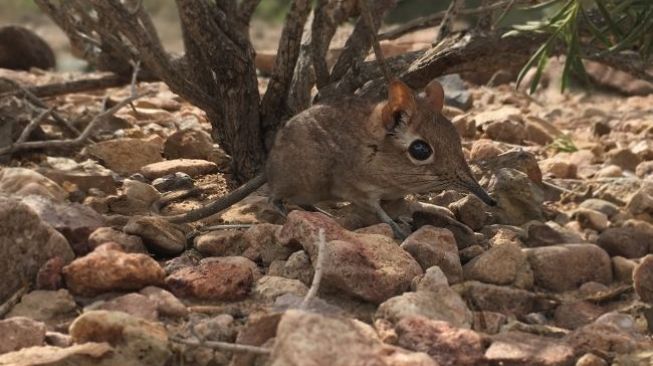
[163,130,213,160]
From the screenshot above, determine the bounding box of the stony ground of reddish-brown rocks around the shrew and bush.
[0,54,653,365]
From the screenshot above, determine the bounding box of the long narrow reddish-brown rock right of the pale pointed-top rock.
[457,281,537,315]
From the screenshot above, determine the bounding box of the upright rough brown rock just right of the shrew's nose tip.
[488,168,544,225]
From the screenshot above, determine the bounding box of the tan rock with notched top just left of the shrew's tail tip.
[107,179,161,216]
